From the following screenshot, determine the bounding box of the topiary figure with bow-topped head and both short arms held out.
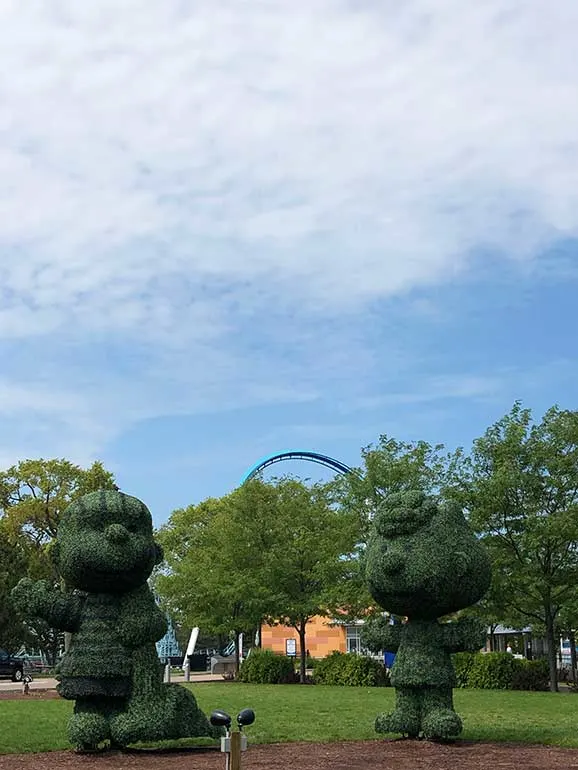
[363,492,491,740]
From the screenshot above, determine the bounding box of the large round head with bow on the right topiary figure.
[366,492,491,620]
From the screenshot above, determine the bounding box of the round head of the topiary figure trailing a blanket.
[53,490,162,593]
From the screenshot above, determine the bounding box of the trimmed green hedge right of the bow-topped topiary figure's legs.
[453,652,550,690]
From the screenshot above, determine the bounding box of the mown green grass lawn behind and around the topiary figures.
[0,682,578,754]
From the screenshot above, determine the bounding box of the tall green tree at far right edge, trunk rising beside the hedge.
[458,402,578,690]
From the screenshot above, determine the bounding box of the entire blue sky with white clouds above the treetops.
[0,0,578,523]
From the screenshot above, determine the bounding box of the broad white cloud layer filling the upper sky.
[0,0,578,462]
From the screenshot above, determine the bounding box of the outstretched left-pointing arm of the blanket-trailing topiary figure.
[11,578,85,632]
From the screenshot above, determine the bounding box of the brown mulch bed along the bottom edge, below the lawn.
[0,740,578,770]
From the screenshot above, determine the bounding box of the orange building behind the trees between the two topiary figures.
[261,617,362,658]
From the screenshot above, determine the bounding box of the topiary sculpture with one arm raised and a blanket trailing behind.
[13,490,217,751]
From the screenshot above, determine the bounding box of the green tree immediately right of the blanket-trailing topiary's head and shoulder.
[155,484,272,671]
